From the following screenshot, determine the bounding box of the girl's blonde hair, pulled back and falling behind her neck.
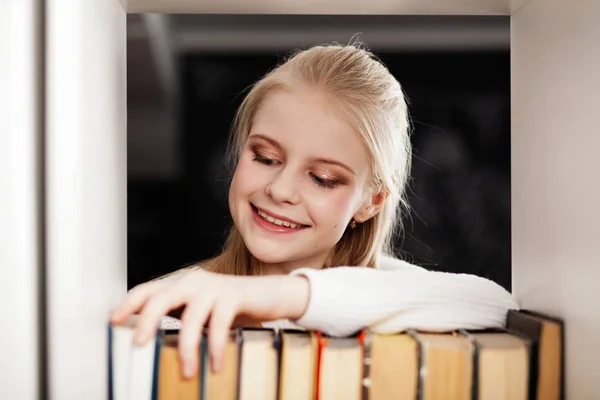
[208,44,411,275]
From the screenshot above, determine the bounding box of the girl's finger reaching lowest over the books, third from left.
[178,296,213,378]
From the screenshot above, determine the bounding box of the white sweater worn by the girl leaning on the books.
[161,256,519,336]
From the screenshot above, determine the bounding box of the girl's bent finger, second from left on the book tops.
[134,289,185,346]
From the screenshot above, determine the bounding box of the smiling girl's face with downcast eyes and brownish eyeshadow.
[229,90,380,271]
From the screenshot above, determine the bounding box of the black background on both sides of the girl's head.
[128,15,510,289]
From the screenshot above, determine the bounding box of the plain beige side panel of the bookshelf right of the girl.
[511,0,600,399]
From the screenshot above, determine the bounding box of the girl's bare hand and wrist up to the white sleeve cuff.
[111,269,309,377]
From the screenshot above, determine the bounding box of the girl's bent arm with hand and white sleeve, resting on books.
[111,258,517,376]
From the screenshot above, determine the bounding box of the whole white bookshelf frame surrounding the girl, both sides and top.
[0,0,600,399]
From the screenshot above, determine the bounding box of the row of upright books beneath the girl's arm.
[109,311,564,400]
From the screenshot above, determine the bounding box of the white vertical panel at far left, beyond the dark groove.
[0,0,42,399]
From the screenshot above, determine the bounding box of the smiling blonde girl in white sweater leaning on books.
[112,45,517,376]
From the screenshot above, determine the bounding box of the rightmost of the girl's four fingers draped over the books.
[208,302,236,372]
